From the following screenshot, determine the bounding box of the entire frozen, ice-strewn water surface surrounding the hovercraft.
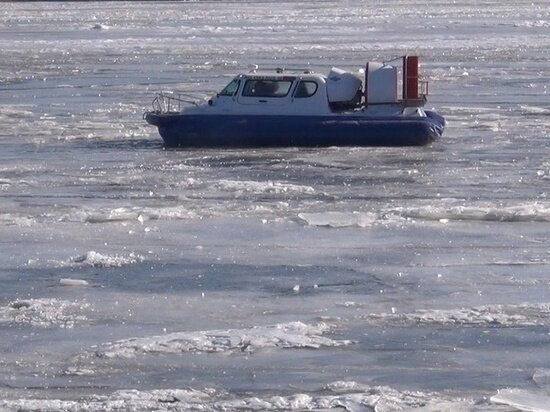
[0,0,550,412]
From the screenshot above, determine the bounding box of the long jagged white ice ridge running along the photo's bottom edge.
[0,382,484,412]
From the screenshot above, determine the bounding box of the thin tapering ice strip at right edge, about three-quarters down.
[368,303,550,326]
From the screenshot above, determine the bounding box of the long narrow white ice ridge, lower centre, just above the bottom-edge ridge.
[86,322,352,358]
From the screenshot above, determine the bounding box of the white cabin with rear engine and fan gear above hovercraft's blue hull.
[205,56,427,115]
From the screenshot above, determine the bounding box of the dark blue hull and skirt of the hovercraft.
[145,111,445,148]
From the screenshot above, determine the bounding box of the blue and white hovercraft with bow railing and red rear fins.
[144,56,445,148]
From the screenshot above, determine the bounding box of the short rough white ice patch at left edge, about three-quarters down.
[0,298,91,328]
